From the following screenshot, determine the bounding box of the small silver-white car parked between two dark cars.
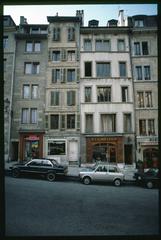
[79,163,124,186]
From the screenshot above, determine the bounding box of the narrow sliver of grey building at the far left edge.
[3,15,17,161]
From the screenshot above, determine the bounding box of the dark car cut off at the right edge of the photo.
[134,168,159,188]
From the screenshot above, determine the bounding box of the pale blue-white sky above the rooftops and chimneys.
[3,4,157,26]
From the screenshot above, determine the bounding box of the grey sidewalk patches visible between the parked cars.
[5,161,135,181]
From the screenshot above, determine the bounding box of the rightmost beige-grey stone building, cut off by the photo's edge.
[128,15,158,168]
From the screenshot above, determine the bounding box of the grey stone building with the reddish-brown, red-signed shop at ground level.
[11,17,48,160]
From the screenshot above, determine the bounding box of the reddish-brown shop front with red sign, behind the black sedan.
[19,132,44,161]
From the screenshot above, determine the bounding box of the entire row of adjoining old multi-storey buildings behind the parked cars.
[4,10,158,167]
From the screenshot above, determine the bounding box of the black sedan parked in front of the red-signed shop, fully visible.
[10,158,68,182]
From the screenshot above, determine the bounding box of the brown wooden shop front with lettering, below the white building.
[86,136,124,163]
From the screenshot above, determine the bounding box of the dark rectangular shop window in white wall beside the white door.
[48,140,66,155]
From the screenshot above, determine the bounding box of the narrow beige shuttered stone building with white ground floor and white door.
[44,11,83,164]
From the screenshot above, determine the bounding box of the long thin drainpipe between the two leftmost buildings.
[8,33,16,162]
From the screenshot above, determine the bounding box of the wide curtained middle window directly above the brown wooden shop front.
[101,114,116,133]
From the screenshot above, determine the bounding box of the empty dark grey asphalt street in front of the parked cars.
[5,176,159,236]
